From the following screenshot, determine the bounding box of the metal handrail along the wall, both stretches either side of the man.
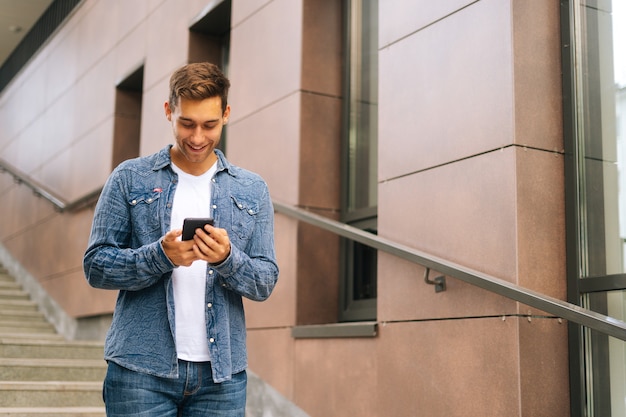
[0,156,626,341]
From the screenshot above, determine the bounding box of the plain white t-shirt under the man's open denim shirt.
[171,163,217,362]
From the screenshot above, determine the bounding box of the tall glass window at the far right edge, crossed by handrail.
[564,0,626,417]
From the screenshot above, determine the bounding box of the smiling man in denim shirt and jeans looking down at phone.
[83,63,278,417]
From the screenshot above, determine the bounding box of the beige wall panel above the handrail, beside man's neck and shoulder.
[226,94,301,204]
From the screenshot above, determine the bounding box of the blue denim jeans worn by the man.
[103,360,248,417]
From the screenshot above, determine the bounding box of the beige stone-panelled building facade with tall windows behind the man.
[0,0,626,417]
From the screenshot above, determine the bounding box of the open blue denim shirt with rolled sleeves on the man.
[83,145,278,382]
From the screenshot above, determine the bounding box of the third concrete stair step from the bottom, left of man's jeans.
[0,358,106,382]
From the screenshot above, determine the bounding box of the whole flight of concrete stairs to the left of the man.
[0,265,106,410]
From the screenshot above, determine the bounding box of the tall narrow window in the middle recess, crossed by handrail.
[340,0,378,321]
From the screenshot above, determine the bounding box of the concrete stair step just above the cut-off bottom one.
[0,381,104,407]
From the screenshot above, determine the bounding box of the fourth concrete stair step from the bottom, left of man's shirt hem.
[0,335,104,360]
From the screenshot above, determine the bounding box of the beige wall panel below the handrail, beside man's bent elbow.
[244,214,298,329]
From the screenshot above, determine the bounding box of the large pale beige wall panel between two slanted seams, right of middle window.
[378,0,513,181]
